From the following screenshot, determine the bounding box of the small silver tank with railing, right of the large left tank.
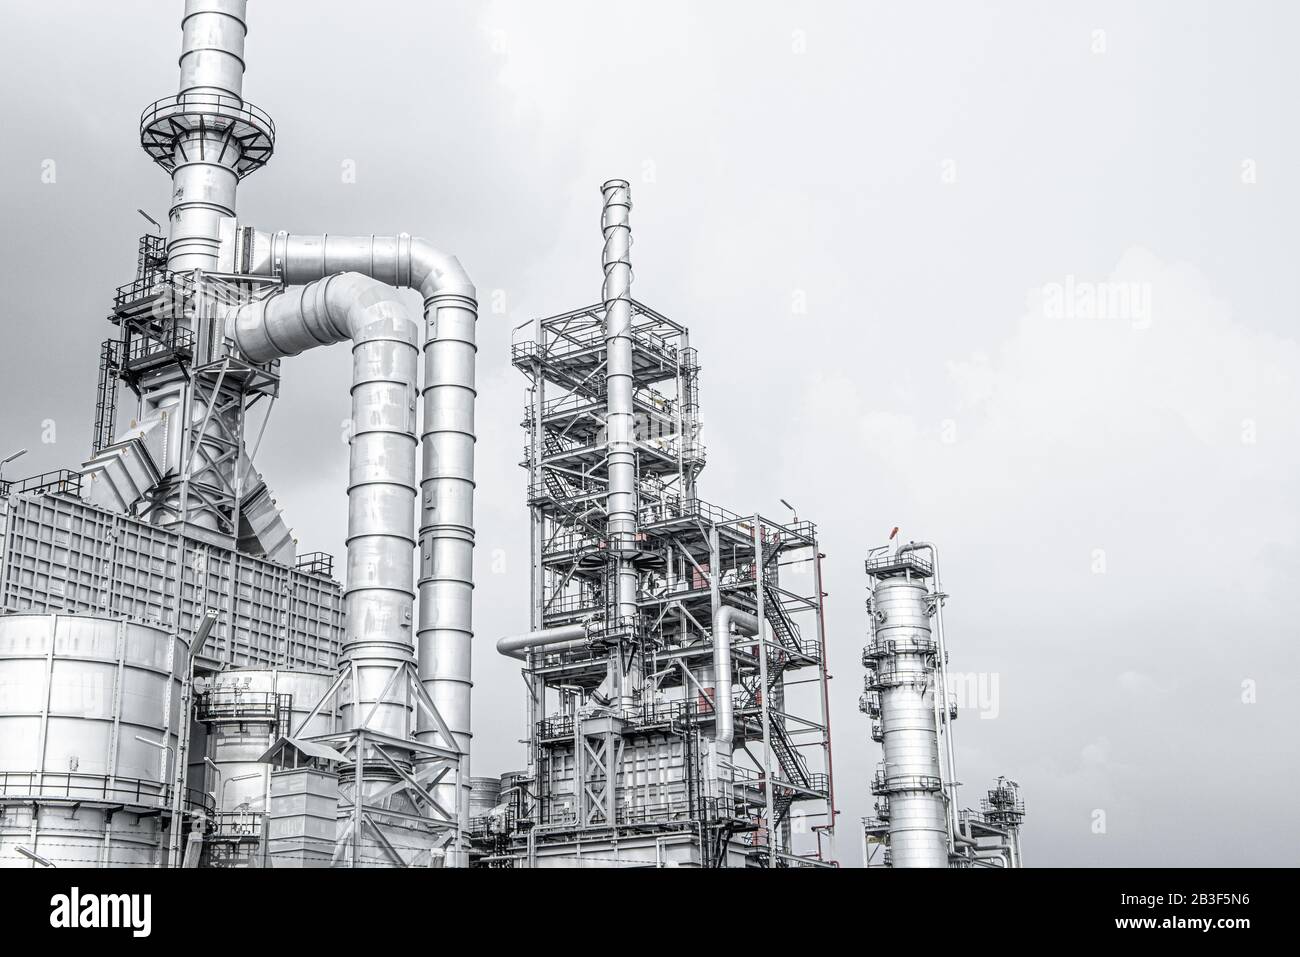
[191,668,337,813]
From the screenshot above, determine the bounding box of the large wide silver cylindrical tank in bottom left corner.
[0,615,190,867]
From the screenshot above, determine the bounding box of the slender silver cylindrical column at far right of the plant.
[868,576,949,867]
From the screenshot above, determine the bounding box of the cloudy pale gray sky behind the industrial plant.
[0,0,1300,866]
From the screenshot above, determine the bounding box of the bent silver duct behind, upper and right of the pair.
[244,230,478,815]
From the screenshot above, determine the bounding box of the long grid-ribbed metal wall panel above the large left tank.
[0,495,343,671]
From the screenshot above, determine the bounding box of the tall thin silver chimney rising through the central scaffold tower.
[601,179,637,696]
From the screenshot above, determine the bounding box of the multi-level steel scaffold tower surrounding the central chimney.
[486,185,833,866]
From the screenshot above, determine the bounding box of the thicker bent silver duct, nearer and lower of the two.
[233,273,420,743]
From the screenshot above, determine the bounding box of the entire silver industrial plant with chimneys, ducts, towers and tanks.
[0,0,1024,869]
